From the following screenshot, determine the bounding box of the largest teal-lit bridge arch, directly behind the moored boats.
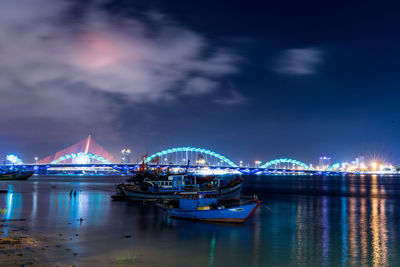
[145,147,238,168]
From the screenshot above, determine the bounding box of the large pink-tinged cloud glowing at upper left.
[0,0,239,138]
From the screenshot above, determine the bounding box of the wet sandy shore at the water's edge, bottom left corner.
[0,220,143,267]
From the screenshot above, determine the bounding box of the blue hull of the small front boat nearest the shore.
[168,202,260,223]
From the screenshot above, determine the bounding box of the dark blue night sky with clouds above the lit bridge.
[0,0,400,164]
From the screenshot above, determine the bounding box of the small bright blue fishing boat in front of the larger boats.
[167,192,260,223]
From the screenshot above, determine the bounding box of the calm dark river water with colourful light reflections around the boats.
[0,176,400,266]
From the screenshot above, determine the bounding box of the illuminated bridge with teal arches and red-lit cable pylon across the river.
[8,142,346,174]
